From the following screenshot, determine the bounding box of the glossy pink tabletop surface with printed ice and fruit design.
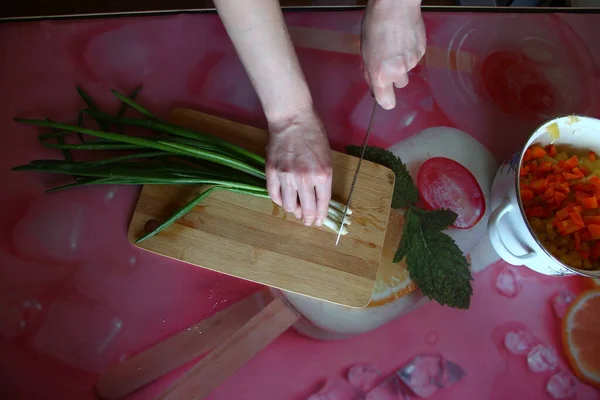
[0,8,600,400]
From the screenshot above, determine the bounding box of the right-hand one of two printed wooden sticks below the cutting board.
[155,297,300,400]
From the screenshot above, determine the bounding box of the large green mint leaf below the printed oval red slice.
[394,207,473,309]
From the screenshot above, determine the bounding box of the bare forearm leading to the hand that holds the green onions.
[214,0,312,121]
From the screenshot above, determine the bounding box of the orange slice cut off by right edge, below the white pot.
[562,289,600,387]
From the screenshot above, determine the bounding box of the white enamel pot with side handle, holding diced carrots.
[488,115,600,278]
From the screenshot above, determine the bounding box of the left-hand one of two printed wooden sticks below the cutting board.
[96,290,271,400]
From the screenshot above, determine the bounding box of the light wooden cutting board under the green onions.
[129,108,395,307]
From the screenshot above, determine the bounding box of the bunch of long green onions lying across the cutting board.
[13,87,352,243]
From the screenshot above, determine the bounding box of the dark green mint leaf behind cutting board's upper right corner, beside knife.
[346,145,419,208]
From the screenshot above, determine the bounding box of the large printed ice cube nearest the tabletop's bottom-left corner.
[33,296,123,372]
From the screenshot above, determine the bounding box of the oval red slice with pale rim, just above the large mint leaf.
[418,157,485,229]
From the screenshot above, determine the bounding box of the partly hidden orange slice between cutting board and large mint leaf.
[368,209,417,307]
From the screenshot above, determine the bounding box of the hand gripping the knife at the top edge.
[361,0,426,110]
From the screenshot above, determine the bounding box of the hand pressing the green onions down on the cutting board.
[266,106,332,226]
